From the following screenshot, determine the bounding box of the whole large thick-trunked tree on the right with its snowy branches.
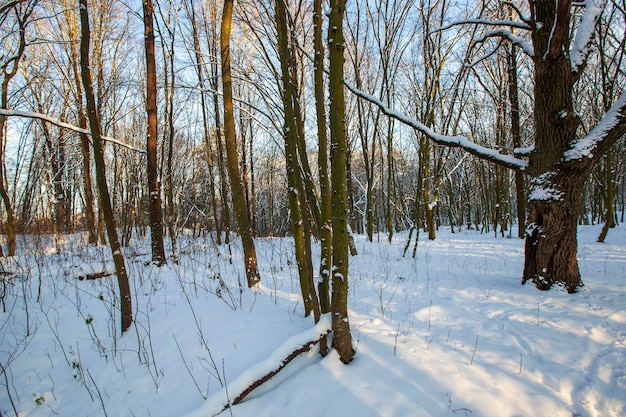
[351,0,626,292]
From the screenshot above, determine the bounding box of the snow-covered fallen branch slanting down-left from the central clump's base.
[179,314,332,417]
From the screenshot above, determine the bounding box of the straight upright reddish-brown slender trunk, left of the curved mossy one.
[143,0,165,266]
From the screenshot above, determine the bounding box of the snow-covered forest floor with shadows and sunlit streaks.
[0,227,626,417]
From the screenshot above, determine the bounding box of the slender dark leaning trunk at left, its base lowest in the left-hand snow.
[79,0,133,333]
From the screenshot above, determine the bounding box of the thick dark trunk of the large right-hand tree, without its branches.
[522,0,586,293]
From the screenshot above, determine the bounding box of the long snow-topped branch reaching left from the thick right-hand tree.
[344,82,528,171]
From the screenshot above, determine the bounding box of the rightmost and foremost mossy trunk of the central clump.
[328,0,354,364]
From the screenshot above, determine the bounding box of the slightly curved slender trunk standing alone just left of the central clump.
[220,0,261,287]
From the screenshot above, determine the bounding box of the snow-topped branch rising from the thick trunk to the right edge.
[563,90,626,162]
